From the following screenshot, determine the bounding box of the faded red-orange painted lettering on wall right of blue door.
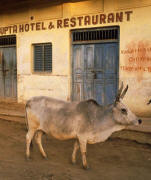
[120,40,151,80]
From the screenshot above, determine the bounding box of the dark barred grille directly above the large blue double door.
[72,27,119,42]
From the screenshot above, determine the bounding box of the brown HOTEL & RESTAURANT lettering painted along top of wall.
[0,11,133,35]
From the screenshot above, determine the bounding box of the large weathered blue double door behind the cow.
[72,42,119,105]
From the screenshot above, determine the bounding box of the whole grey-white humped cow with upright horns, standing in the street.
[26,83,142,169]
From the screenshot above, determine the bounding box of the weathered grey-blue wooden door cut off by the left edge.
[0,47,17,99]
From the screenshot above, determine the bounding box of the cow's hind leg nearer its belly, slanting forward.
[35,130,47,158]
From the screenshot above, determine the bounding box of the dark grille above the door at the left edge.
[0,36,16,46]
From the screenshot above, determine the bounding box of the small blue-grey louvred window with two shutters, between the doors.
[34,43,52,72]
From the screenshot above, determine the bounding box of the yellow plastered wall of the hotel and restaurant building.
[0,0,151,116]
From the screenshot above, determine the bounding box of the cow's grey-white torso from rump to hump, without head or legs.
[26,96,108,139]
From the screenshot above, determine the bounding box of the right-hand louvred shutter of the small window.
[44,44,52,71]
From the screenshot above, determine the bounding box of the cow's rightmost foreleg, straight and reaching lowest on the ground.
[79,139,89,169]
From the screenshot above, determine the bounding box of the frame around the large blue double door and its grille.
[70,26,120,101]
